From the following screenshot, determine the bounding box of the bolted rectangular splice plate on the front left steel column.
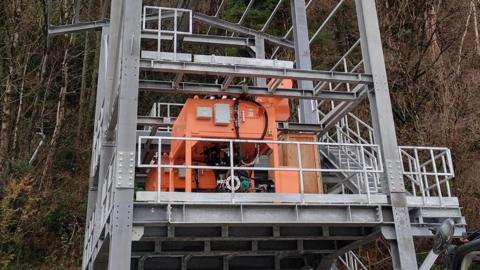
[115,151,135,188]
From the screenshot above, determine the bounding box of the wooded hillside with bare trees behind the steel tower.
[0,0,480,269]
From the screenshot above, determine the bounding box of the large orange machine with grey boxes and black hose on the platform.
[146,80,316,193]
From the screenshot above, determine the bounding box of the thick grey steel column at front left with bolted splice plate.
[108,0,142,270]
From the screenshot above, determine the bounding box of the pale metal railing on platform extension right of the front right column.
[399,146,455,198]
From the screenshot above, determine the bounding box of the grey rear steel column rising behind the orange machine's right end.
[290,0,320,124]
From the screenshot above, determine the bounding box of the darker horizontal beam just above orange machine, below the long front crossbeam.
[139,80,358,102]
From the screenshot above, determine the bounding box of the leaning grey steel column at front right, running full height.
[355,0,418,269]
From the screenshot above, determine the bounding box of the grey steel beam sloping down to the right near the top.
[193,13,293,48]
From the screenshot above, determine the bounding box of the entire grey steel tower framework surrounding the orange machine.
[47,0,466,270]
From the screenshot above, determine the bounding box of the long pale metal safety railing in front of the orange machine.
[137,136,383,201]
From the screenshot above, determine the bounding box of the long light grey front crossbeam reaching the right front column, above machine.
[140,60,373,84]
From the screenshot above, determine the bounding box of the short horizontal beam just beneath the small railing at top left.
[142,31,255,47]
